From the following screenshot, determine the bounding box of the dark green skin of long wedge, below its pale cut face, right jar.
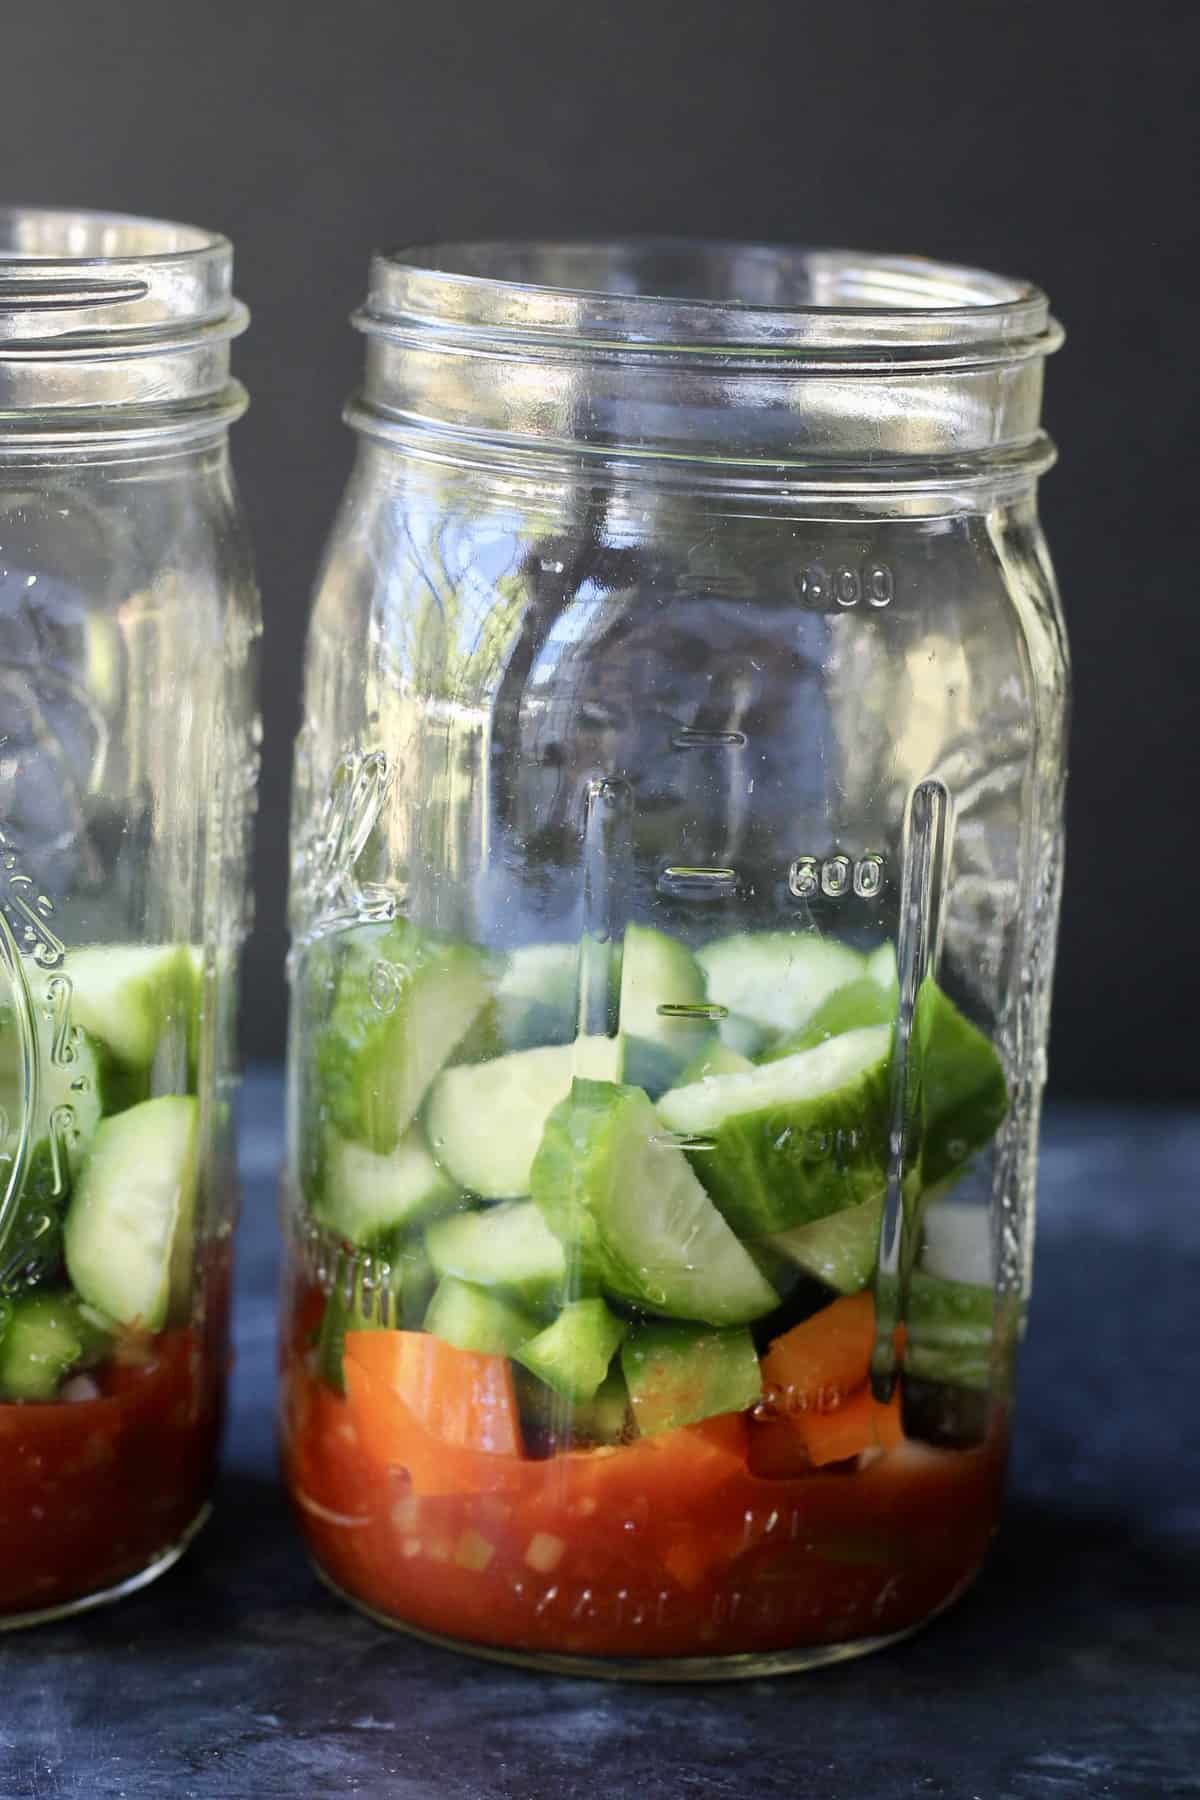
[662,1048,891,1238]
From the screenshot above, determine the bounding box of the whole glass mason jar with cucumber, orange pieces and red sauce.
[284,241,1067,1678]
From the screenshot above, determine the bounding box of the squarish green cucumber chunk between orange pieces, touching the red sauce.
[621,1325,763,1438]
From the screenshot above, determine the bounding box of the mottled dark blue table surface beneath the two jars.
[0,1073,1200,1800]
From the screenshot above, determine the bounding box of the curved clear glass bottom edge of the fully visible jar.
[309,1557,979,1685]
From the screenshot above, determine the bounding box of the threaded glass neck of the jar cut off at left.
[0,207,246,448]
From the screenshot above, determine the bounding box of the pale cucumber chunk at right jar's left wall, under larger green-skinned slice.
[311,1125,459,1246]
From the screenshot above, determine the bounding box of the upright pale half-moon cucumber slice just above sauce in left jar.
[63,1094,198,1330]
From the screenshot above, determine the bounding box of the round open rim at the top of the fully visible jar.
[354,238,1061,364]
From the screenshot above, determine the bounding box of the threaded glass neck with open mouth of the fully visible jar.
[351,239,1061,475]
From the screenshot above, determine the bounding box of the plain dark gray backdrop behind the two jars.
[0,0,1200,1098]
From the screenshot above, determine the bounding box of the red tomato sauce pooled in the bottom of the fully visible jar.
[282,1296,1004,1658]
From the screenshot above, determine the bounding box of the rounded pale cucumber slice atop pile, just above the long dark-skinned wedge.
[698,931,864,1053]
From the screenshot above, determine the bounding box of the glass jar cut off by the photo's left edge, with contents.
[0,211,259,1627]
